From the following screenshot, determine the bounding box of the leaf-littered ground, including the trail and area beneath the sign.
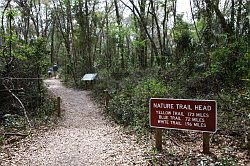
[0,78,250,166]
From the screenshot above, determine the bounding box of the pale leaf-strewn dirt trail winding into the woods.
[0,79,146,166]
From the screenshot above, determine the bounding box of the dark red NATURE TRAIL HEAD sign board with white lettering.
[149,98,217,132]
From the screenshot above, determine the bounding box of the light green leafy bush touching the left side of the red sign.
[107,75,167,131]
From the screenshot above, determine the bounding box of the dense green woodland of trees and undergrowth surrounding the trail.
[0,0,250,165]
